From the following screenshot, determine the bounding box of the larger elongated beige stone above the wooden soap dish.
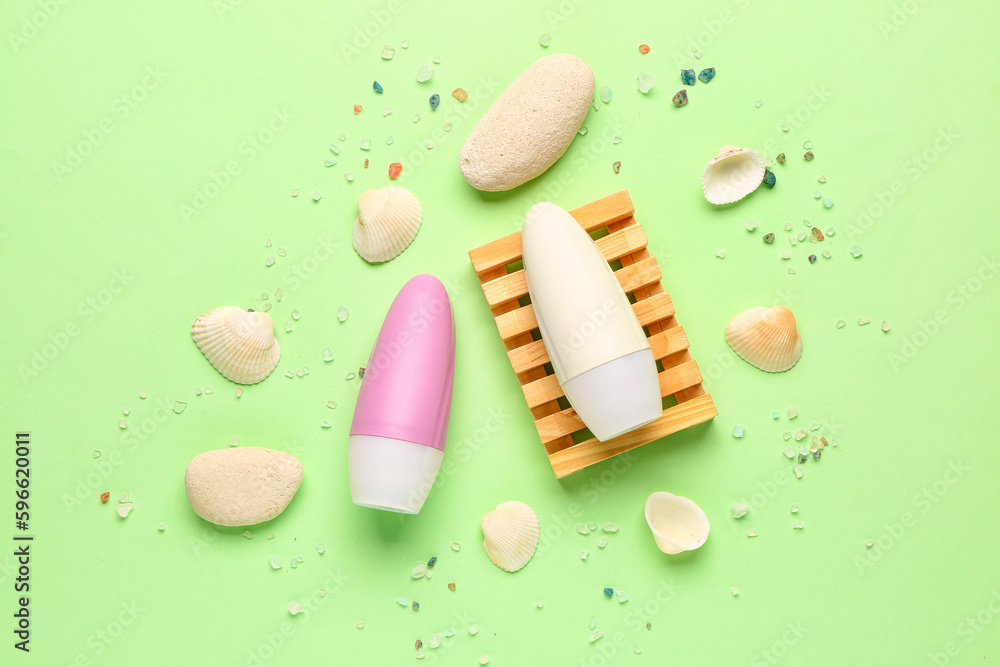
[459,54,595,192]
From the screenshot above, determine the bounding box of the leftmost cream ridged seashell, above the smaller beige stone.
[191,306,281,384]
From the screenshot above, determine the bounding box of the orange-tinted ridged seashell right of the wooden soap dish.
[726,306,802,373]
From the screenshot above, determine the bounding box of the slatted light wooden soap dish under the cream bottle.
[469,190,718,477]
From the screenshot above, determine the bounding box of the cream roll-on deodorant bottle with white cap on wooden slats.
[522,202,663,441]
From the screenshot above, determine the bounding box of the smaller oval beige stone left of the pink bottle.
[184,447,302,526]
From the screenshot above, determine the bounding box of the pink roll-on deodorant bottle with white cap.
[349,274,455,514]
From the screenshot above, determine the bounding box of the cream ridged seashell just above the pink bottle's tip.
[353,185,423,262]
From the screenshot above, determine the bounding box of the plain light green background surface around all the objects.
[0,0,1000,666]
